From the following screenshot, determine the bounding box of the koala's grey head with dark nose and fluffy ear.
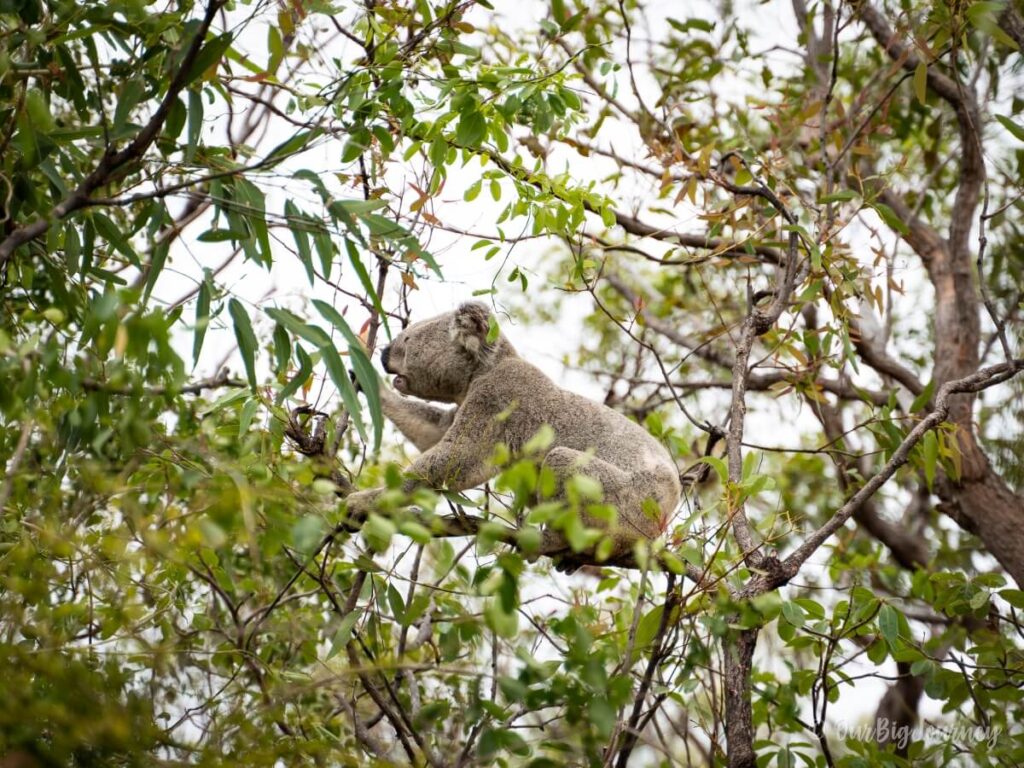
[381,301,515,402]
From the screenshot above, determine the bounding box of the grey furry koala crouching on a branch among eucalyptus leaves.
[348,302,681,570]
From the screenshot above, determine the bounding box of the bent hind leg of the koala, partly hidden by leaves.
[541,447,662,570]
